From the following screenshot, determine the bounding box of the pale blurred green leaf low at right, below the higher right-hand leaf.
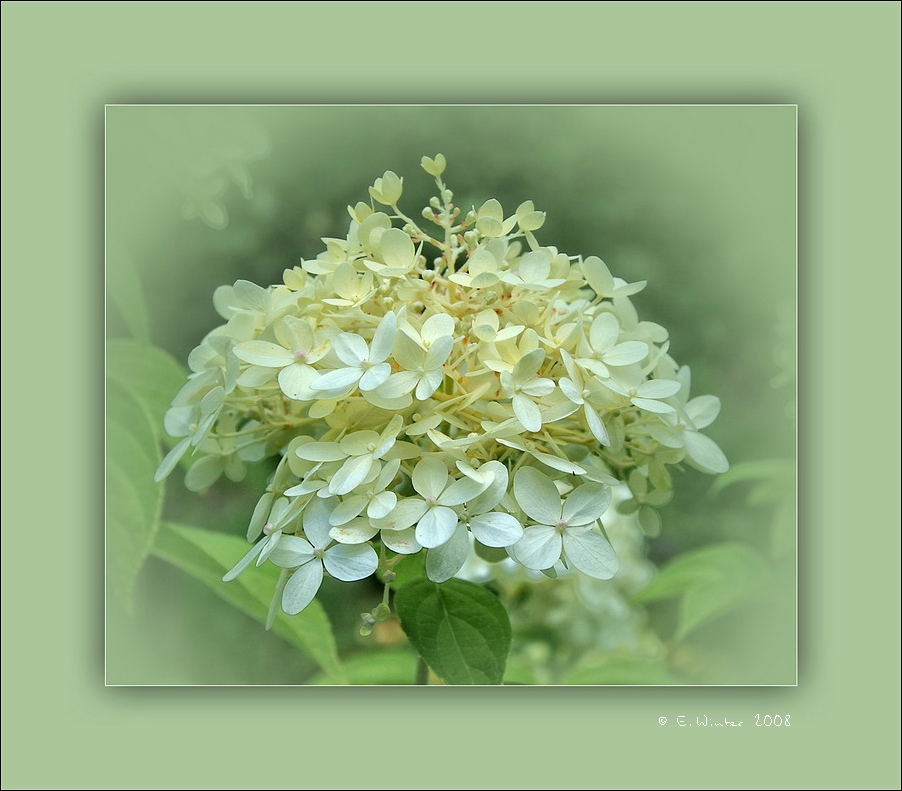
[636,543,769,639]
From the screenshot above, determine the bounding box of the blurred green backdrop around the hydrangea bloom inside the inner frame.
[106,106,796,684]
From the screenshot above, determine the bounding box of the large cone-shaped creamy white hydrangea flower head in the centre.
[157,154,728,617]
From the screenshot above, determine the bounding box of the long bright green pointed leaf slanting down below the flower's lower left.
[153,523,347,684]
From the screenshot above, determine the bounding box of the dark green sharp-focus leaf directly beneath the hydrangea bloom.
[395,579,511,684]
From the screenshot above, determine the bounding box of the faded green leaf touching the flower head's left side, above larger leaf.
[106,338,185,436]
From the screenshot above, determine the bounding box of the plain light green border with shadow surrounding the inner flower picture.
[2,2,899,788]
